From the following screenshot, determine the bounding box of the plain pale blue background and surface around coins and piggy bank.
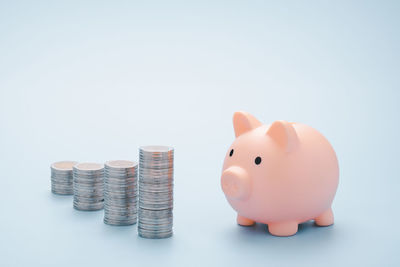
[0,1,400,266]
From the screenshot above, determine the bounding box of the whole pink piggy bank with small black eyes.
[221,112,339,236]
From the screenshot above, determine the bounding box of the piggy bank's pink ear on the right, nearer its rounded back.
[267,121,298,152]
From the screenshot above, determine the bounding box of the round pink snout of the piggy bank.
[221,166,250,200]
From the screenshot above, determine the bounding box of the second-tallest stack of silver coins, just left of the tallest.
[104,160,138,225]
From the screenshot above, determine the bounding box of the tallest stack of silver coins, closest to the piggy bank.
[138,146,174,238]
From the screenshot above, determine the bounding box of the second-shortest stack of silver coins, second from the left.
[73,163,104,210]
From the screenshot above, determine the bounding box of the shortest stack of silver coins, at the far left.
[50,161,77,195]
